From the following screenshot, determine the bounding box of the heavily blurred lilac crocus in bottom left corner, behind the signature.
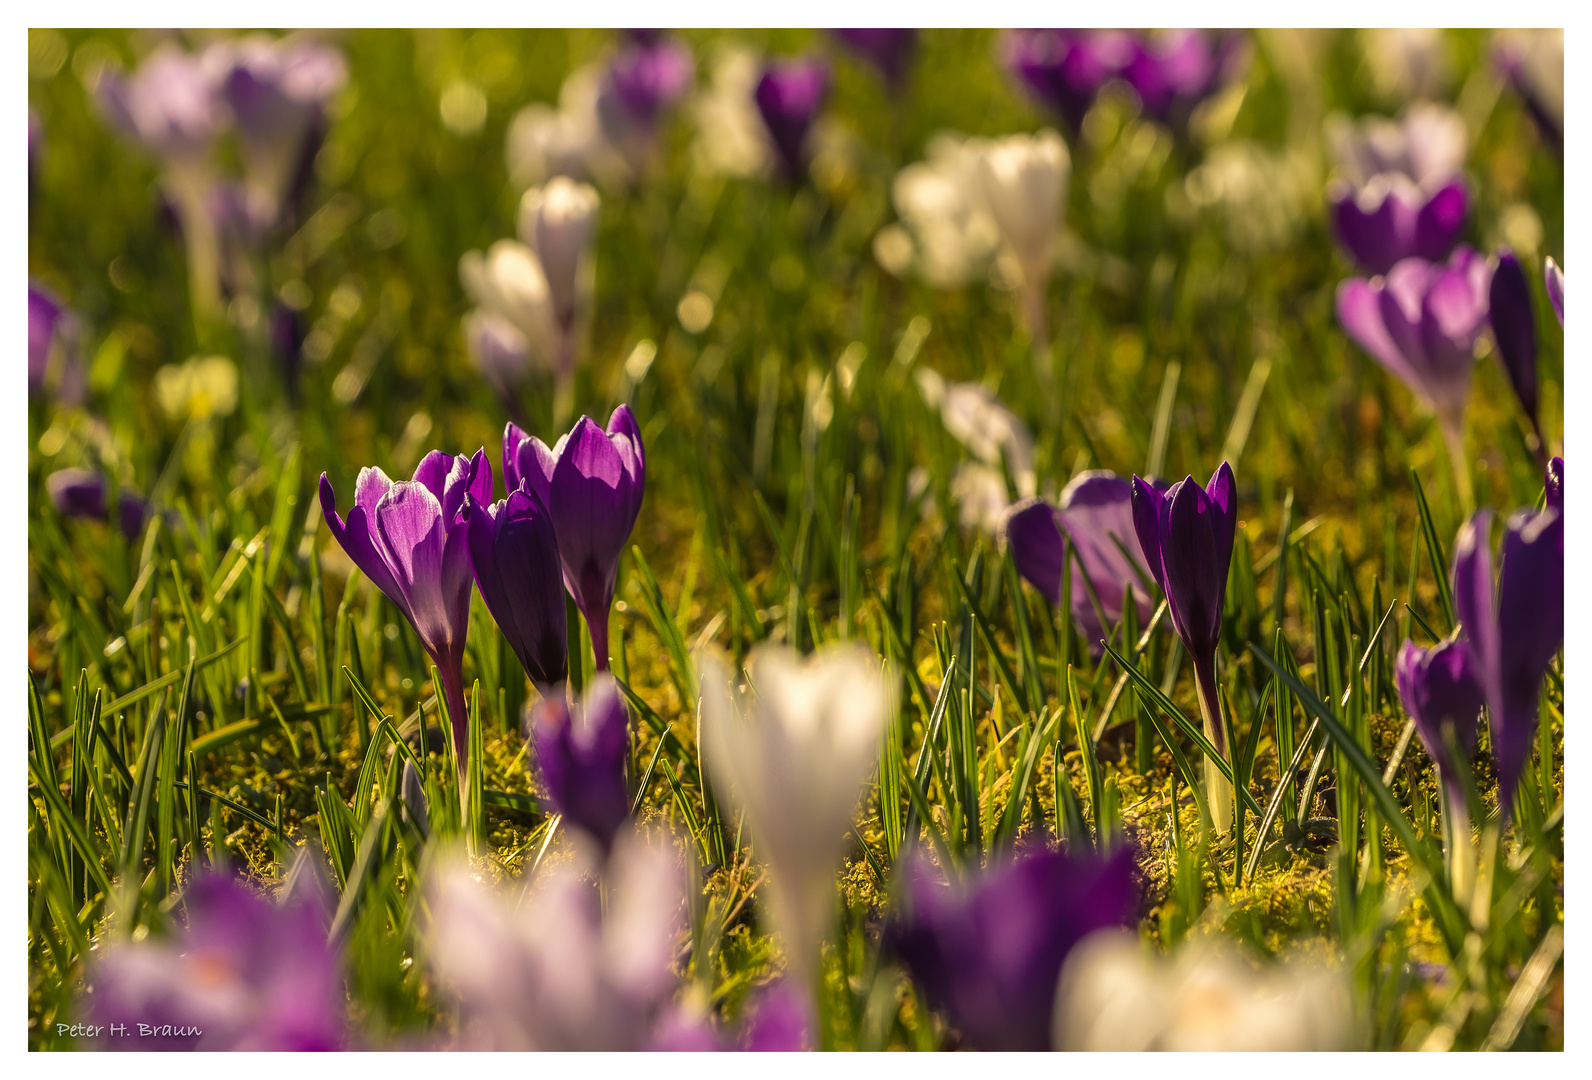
[81,859,347,1051]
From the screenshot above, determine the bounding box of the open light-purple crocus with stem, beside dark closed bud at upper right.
[1337,244,1490,507]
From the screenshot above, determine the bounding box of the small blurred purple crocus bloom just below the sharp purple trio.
[530,672,630,852]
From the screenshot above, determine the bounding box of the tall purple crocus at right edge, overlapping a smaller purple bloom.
[1453,507,1565,816]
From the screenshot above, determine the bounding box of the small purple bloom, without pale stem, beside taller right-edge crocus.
[1393,639,1482,814]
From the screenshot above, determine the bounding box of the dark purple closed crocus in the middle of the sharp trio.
[465,484,570,696]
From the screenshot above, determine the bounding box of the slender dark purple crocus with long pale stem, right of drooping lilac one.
[1134,462,1239,832]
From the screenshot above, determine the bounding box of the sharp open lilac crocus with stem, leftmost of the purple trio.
[320,451,492,771]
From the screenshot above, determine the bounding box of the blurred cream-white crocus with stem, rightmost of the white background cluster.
[979,129,1071,341]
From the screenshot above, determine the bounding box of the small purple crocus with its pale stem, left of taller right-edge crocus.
[1393,639,1482,897]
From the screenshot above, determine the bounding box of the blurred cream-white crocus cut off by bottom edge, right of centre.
[1051,930,1353,1051]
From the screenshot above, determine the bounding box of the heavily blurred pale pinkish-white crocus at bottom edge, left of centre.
[427,833,686,1050]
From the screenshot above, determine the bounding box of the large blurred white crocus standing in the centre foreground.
[699,645,892,986]
